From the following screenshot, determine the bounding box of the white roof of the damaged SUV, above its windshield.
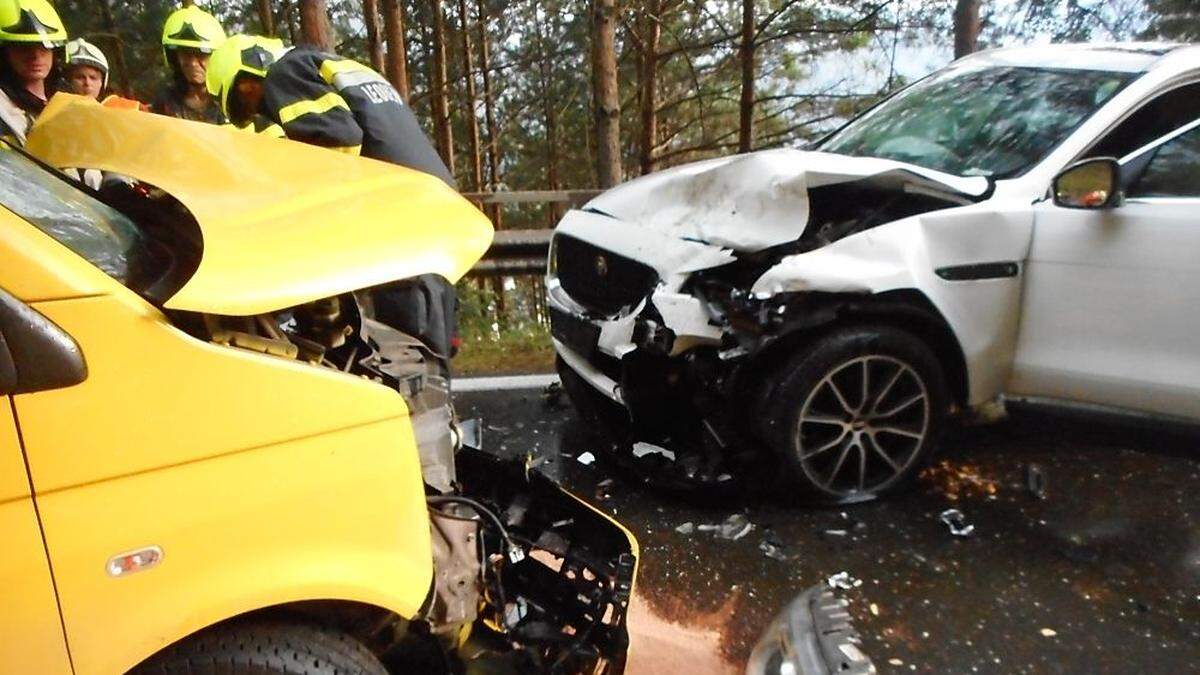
[955,42,1200,72]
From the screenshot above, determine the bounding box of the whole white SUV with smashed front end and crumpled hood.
[547,44,1200,502]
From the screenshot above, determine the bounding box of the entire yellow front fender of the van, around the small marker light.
[13,294,432,674]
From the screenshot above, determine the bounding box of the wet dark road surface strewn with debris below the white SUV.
[457,390,1200,675]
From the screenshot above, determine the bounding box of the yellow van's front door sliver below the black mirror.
[0,396,71,673]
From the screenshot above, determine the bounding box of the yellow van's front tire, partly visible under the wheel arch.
[133,621,388,675]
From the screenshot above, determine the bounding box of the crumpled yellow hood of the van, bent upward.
[28,94,492,316]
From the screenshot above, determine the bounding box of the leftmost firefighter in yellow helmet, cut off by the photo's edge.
[0,0,67,145]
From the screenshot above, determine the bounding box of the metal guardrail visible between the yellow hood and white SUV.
[462,190,602,276]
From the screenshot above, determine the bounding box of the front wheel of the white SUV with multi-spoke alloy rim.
[762,324,948,503]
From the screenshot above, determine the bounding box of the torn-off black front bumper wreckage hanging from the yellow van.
[427,448,638,674]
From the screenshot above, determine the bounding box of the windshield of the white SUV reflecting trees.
[820,66,1138,178]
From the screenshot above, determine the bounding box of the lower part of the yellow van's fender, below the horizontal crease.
[38,420,432,675]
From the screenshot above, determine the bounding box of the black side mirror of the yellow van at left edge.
[0,291,88,395]
